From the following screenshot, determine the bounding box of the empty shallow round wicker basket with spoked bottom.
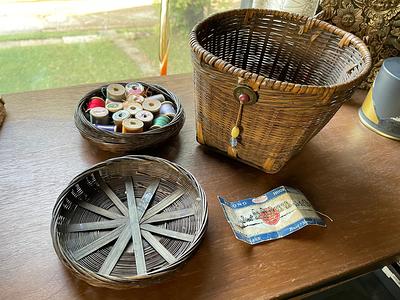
[51,155,208,289]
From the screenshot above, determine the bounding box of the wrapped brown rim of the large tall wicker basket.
[189,8,372,94]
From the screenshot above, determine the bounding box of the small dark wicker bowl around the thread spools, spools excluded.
[74,82,185,153]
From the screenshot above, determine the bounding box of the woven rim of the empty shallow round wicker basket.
[50,155,208,288]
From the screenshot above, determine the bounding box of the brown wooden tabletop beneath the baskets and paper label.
[0,75,400,300]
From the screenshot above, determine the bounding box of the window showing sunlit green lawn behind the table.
[0,0,240,94]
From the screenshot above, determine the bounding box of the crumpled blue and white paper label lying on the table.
[218,186,326,245]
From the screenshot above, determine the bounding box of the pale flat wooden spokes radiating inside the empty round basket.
[66,173,194,275]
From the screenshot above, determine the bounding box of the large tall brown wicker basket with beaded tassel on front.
[190,9,371,173]
